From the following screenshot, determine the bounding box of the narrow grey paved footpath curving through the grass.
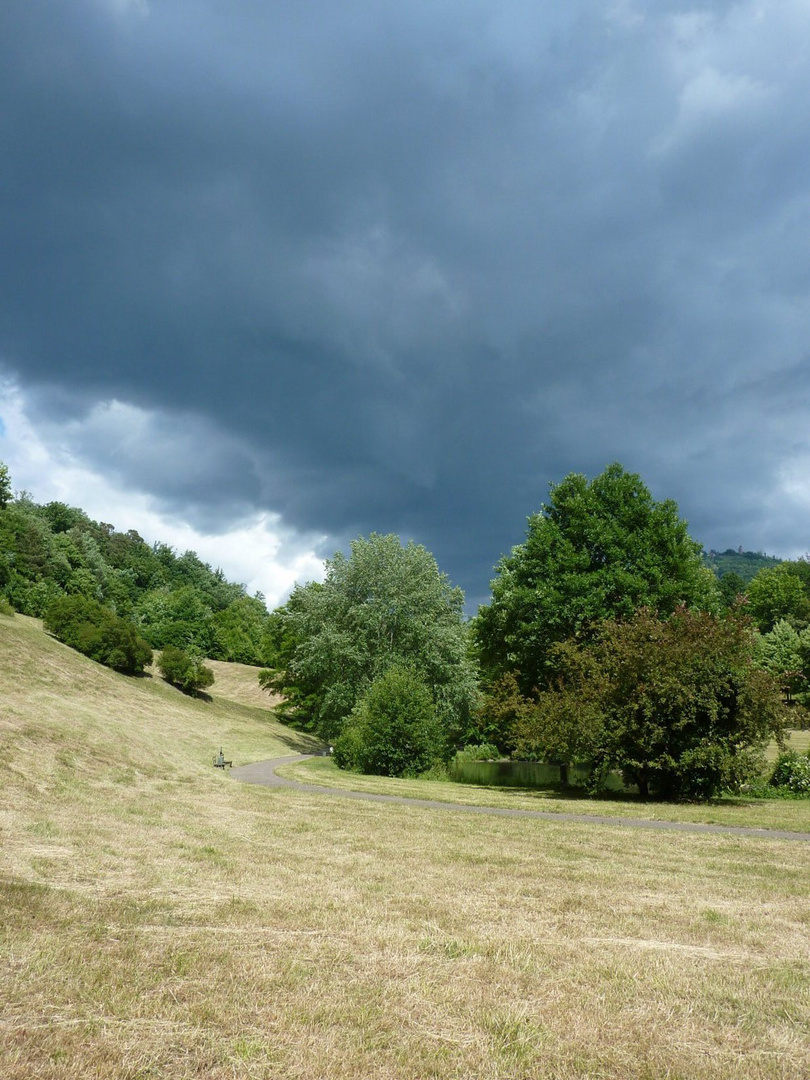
[231,754,810,842]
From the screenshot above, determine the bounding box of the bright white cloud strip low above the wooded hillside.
[0,381,325,607]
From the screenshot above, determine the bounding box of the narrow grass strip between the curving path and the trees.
[278,756,810,833]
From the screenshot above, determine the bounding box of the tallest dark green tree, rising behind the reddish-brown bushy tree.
[475,464,719,693]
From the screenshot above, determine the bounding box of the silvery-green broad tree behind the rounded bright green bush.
[261,534,477,740]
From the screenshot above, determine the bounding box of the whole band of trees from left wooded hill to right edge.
[6,463,810,798]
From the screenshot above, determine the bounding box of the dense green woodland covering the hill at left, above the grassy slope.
[0,462,269,664]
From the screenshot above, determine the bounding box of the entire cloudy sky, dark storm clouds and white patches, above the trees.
[0,0,810,607]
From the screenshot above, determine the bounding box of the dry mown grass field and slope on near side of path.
[0,617,810,1080]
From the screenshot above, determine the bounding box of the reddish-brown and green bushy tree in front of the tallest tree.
[517,607,785,798]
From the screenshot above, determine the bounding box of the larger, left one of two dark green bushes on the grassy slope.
[44,596,152,675]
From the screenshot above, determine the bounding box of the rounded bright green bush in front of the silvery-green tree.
[334,666,444,777]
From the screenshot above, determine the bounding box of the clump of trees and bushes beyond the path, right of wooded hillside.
[260,464,810,798]
